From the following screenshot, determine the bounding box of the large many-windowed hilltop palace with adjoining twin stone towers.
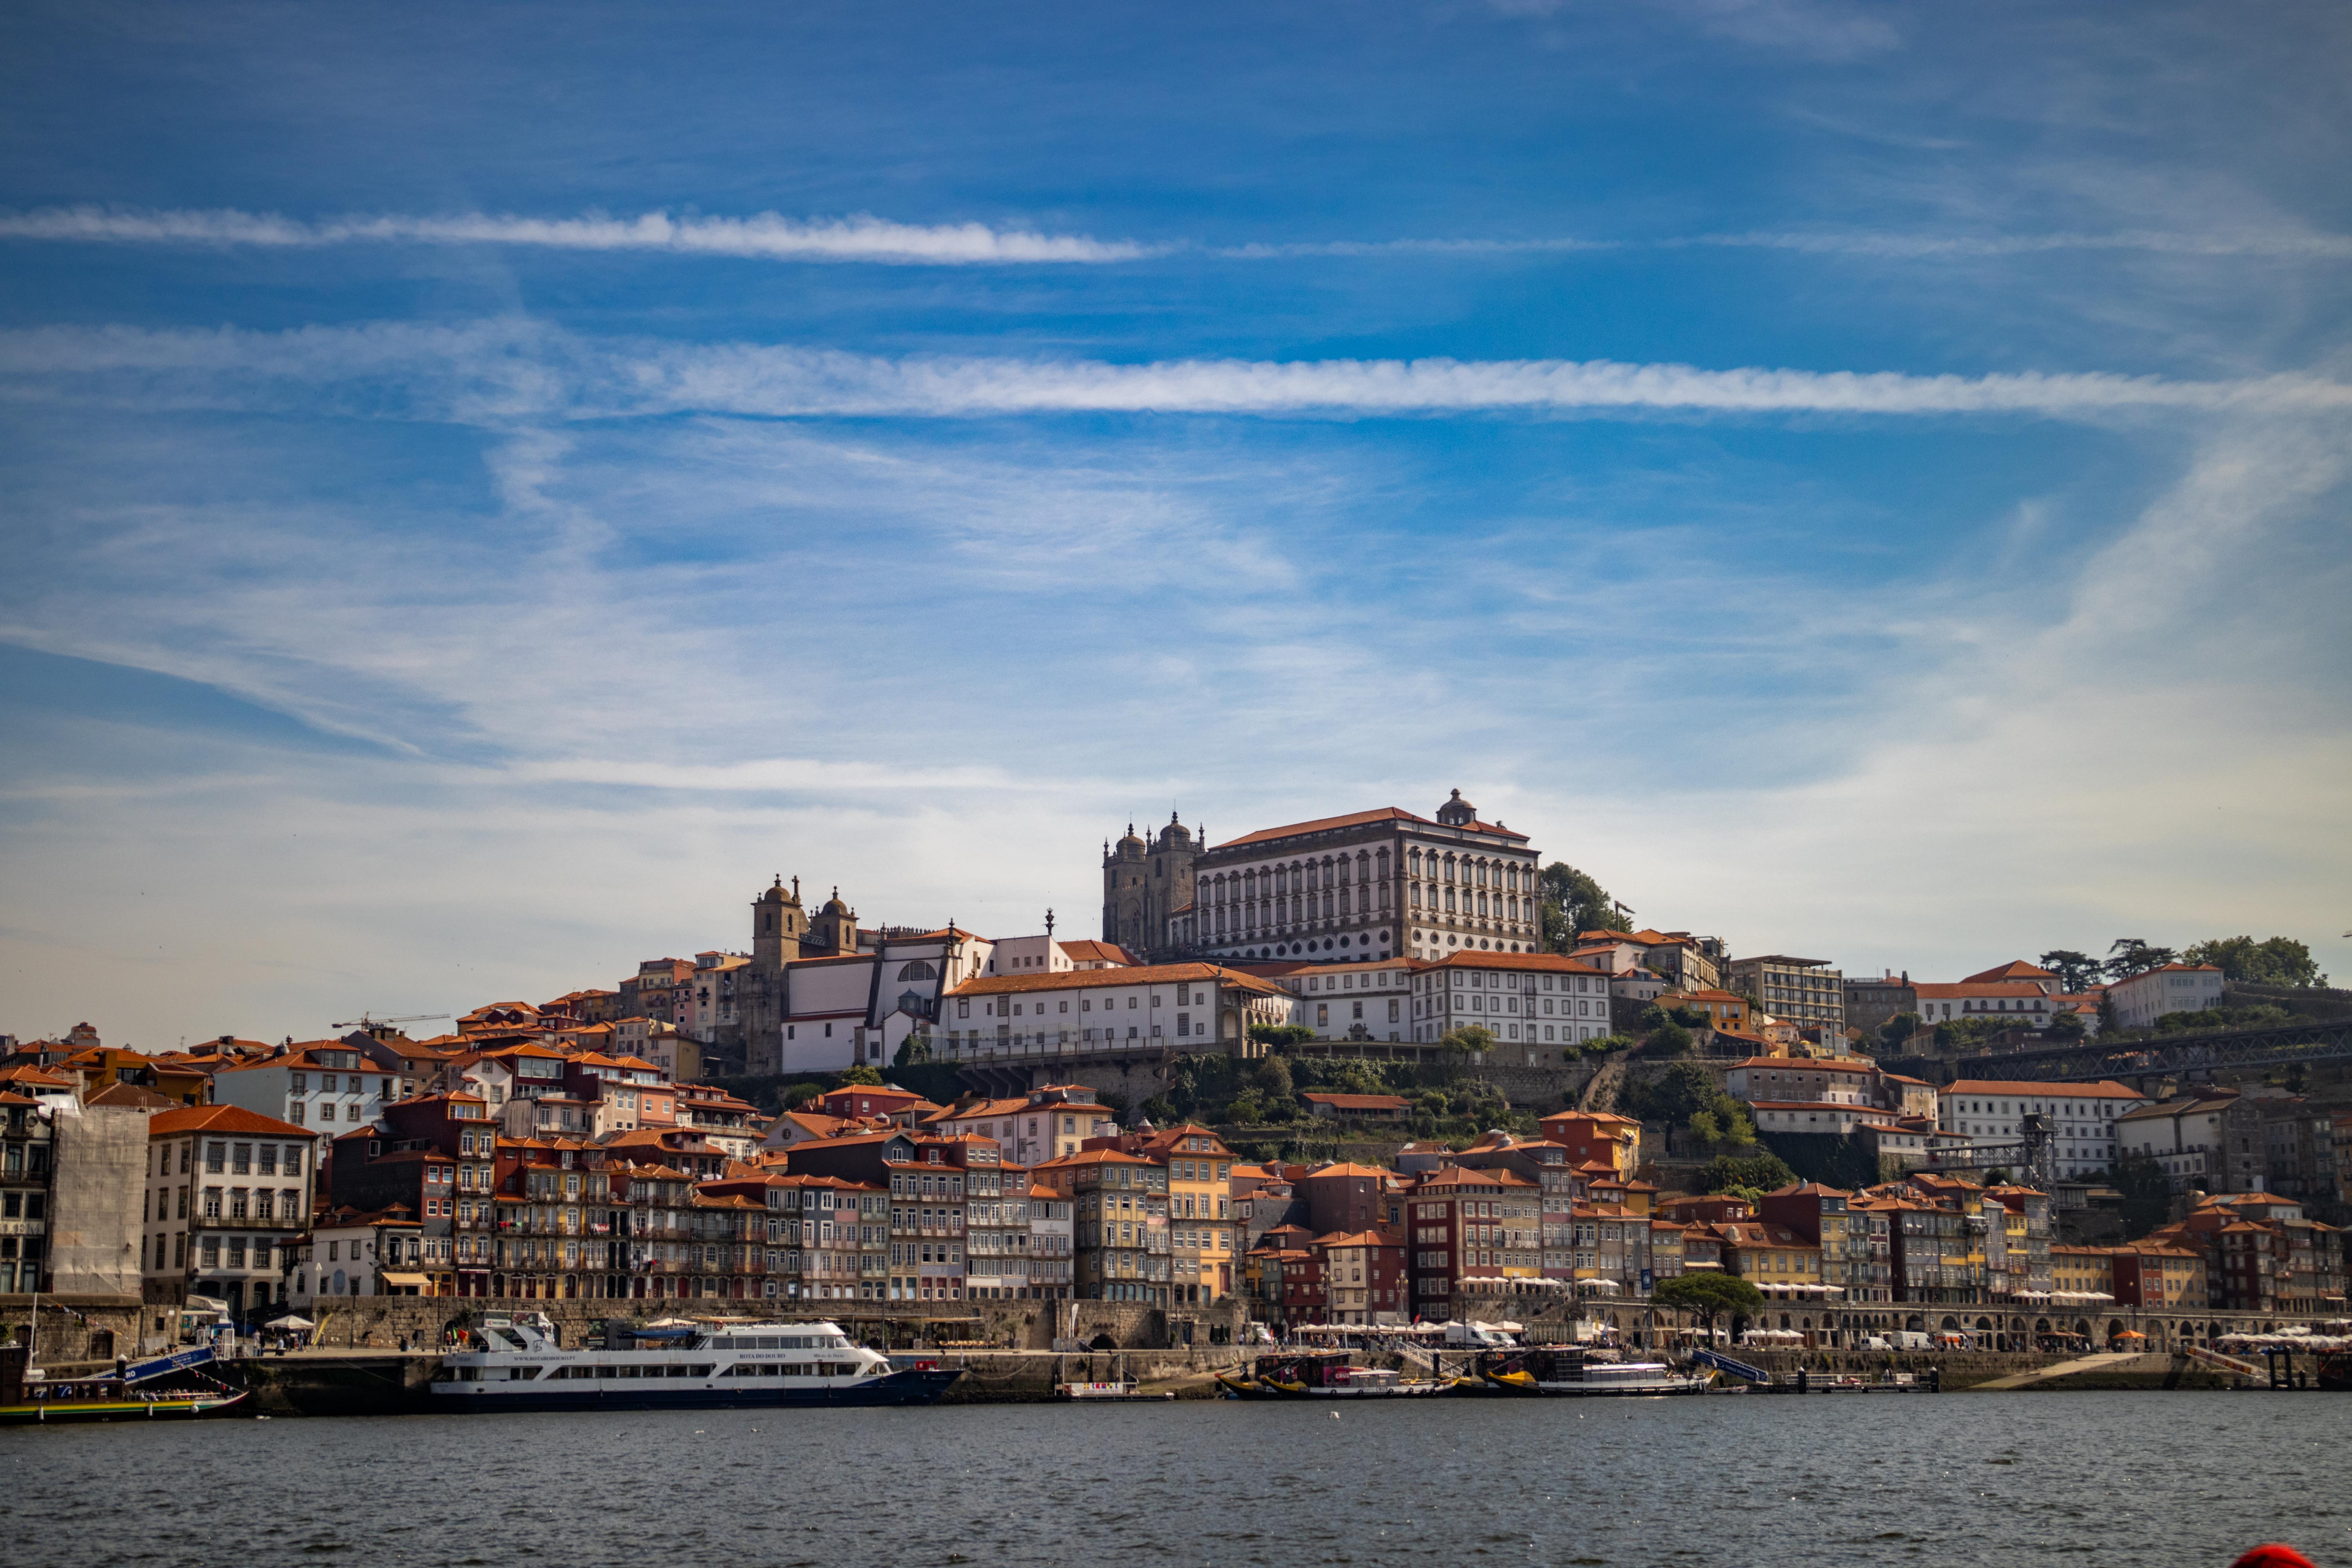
[1103,790,1543,964]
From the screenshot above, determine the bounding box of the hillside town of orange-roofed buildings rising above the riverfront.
[0,792,2352,1349]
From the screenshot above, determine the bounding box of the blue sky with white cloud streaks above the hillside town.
[0,0,2352,1049]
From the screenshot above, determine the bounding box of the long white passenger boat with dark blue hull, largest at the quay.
[433,1312,964,1410]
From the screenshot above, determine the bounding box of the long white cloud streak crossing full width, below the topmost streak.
[0,320,2352,423]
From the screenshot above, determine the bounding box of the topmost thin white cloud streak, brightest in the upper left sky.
[0,205,1155,266]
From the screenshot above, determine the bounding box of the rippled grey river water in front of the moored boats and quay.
[0,1392,2352,1568]
